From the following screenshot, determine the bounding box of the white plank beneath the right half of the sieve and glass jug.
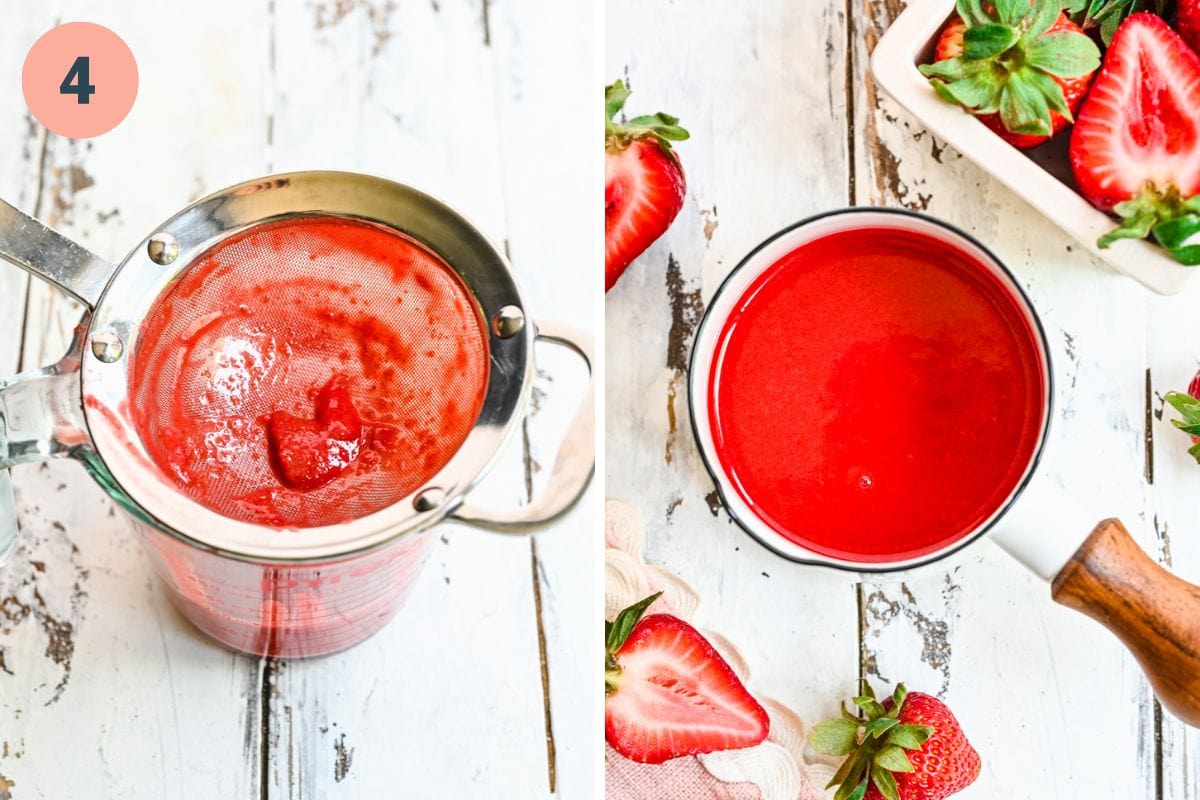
[266,0,561,798]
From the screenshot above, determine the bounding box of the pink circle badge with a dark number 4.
[20,23,138,139]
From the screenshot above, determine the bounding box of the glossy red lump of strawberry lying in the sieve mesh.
[260,378,362,492]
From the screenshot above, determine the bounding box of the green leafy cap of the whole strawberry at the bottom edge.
[809,680,934,800]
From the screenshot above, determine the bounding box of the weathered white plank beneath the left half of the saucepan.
[605,0,858,738]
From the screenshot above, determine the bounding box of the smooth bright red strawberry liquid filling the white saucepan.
[708,229,1048,564]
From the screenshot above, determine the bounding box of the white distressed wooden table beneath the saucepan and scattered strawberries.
[605,0,1200,800]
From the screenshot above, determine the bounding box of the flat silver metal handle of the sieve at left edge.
[0,200,116,308]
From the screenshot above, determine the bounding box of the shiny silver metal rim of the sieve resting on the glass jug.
[80,172,535,564]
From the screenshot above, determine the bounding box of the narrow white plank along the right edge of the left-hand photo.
[488,0,602,798]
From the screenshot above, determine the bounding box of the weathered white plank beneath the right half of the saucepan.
[851,0,1156,799]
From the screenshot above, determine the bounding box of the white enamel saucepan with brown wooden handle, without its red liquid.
[689,209,1200,726]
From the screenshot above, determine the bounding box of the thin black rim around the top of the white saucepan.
[688,206,1055,575]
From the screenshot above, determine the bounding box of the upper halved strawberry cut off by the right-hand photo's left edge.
[604,80,688,291]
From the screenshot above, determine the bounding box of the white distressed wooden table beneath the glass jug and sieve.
[0,0,600,800]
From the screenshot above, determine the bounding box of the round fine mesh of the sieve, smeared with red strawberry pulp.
[130,217,488,528]
